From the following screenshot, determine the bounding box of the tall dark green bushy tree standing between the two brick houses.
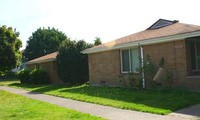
[57,40,93,84]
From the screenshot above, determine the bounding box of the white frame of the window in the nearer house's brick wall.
[120,47,140,73]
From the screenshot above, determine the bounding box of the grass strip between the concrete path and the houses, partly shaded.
[0,81,200,115]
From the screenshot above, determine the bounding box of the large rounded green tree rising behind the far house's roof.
[24,27,67,61]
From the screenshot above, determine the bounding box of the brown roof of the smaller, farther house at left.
[26,52,58,65]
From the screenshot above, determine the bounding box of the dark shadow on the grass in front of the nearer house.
[60,86,200,111]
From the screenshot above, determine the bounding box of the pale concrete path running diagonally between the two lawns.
[0,86,200,120]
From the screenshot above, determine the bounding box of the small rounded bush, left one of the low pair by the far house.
[17,69,31,83]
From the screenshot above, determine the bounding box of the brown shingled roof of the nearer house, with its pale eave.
[82,19,200,54]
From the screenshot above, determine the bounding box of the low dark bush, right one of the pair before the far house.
[30,69,49,84]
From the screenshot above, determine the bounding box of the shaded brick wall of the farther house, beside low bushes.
[27,61,62,84]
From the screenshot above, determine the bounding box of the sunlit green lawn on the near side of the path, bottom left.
[0,90,101,120]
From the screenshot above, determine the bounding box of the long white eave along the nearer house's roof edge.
[82,30,200,54]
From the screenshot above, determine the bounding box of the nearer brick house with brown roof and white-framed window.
[82,19,200,88]
